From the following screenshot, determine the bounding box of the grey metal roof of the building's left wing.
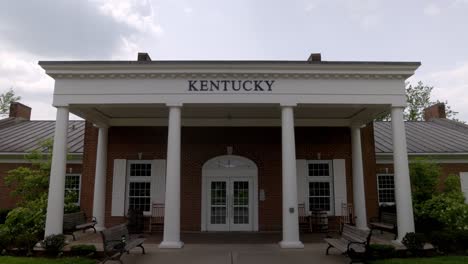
[0,121,85,154]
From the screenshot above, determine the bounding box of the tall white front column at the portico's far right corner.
[392,107,414,241]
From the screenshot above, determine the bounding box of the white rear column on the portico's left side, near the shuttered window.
[93,127,108,230]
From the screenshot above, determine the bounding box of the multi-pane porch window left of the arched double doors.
[127,160,152,212]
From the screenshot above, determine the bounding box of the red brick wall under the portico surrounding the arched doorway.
[100,127,358,231]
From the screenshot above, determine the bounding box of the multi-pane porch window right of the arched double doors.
[307,160,334,213]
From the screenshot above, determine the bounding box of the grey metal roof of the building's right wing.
[374,119,468,154]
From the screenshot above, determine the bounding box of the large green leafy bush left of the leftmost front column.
[0,139,79,254]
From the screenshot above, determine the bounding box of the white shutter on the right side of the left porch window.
[151,160,166,203]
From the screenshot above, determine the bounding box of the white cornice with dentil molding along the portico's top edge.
[40,61,419,79]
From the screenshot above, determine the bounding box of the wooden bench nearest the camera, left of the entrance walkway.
[101,224,145,264]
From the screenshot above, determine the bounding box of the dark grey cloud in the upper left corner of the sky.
[0,0,135,59]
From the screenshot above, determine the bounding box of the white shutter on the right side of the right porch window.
[333,159,347,216]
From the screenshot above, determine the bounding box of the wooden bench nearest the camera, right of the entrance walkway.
[325,224,372,263]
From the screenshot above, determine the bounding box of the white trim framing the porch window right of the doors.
[305,160,335,215]
